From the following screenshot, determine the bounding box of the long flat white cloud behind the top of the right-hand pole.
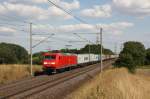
[58,22,134,35]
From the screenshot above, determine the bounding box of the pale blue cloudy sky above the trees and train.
[0,0,150,52]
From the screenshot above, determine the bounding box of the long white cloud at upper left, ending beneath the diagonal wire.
[0,2,72,20]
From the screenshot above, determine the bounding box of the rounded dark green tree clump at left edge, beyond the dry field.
[0,43,28,64]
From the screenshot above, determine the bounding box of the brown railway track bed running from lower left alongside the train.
[0,61,112,99]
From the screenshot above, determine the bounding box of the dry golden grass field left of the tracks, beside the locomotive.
[0,64,42,84]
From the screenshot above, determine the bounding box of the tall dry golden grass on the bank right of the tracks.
[67,68,150,99]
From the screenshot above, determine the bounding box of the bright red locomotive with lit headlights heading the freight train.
[43,53,77,72]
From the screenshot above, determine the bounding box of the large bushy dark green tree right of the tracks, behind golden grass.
[115,41,146,72]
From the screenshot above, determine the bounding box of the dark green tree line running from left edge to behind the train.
[0,43,113,65]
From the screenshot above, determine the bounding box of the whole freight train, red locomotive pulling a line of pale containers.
[43,53,117,73]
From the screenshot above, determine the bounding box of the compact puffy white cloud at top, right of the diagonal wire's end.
[81,4,112,18]
